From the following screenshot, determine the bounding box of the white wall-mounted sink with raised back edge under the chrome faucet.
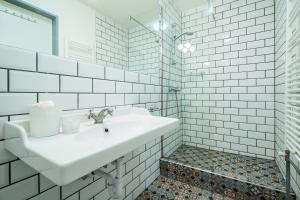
[4,108,179,186]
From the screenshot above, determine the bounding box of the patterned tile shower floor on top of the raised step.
[164,145,285,191]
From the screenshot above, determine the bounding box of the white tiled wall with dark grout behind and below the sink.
[0,46,178,200]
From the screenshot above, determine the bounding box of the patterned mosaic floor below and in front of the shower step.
[136,176,233,200]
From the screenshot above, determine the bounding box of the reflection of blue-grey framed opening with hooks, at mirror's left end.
[0,0,58,55]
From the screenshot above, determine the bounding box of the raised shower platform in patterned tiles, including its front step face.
[160,145,295,200]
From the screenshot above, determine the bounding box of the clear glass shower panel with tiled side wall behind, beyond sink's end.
[160,0,182,157]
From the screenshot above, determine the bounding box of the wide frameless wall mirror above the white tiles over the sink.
[0,0,161,76]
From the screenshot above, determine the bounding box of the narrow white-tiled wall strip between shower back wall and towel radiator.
[275,0,300,194]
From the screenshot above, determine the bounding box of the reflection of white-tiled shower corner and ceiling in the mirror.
[82,0,160,76]
